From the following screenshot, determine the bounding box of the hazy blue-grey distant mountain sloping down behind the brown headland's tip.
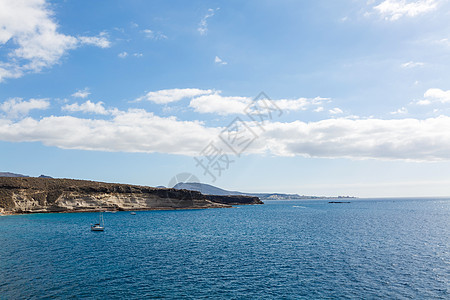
[174,182,304,200]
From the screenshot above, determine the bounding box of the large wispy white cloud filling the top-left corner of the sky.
[0,0,110,82]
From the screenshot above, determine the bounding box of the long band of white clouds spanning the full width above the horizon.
[0,88,450,161]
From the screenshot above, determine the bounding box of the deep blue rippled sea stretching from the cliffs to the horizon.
[0,199,450,299]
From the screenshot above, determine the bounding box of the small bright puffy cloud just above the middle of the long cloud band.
[189,92,252,115]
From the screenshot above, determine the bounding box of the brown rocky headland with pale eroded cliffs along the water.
[0,177,259,213]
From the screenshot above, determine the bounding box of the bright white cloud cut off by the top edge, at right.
[374,0,438,21]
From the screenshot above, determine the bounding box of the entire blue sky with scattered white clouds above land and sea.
[0,0,450,197]
